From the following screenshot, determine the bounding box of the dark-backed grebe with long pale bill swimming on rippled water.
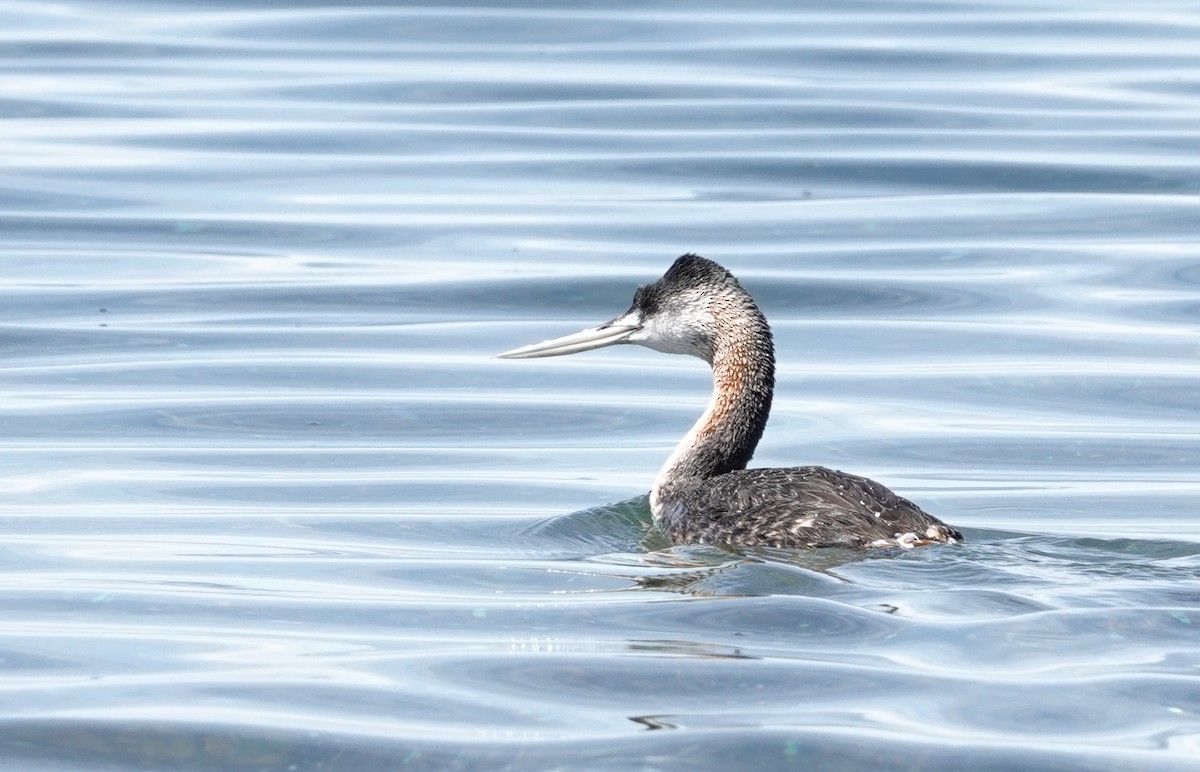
[500,255,962,549]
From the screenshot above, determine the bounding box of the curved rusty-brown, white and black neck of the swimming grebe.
[652,307,775,505]
